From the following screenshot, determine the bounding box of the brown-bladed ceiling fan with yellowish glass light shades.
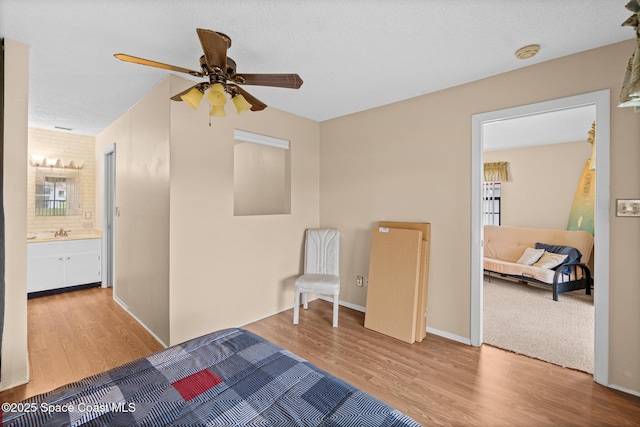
[114,28,302,117]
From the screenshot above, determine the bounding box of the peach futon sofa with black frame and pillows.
[483,225,593,301]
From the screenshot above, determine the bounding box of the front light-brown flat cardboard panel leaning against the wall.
[364,227,422,344]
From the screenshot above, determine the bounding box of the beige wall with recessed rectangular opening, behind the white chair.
[170,77,320,344]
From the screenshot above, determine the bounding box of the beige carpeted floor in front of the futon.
[483,276,594,373]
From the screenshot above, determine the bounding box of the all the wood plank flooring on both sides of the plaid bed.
[0,288,640,426]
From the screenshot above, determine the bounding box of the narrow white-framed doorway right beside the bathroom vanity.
[102,144,116,288]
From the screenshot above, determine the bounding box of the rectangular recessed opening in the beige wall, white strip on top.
[233,129,291,216]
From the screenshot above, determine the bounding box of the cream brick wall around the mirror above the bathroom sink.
[27,128,96,233]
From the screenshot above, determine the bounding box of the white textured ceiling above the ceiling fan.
[0,0,634,135]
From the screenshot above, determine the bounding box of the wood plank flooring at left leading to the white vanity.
[0,288,162,402]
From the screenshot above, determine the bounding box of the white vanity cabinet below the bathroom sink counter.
[27,239,102,293]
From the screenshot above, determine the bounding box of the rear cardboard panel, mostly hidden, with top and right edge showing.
[378,221,431,342]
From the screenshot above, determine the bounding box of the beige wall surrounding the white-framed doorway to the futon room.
[320,41,640,392]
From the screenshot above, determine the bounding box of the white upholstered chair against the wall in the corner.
[293,228,340,328]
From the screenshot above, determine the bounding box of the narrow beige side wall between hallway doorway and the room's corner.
[96,80,171,344]
